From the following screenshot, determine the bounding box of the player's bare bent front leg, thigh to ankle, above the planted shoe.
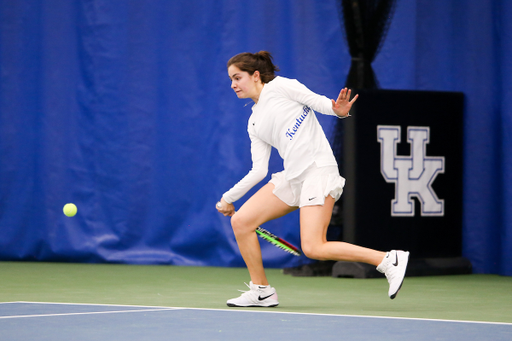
[231,183,297,285]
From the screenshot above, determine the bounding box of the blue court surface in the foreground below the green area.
[0,302,512,341]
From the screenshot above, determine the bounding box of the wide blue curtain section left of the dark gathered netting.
[0,0,348,266]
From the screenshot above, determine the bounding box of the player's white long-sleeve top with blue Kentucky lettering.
[223,77,337,203]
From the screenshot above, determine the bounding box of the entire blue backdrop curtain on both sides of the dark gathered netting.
[0,0,512,275]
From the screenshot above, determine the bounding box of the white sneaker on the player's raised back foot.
[377,250,409,299]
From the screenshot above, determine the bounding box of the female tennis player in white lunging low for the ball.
[216,51,409,307]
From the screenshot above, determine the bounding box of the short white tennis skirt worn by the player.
[269,163,345,207]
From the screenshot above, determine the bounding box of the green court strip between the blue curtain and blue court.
[0,262,512,323]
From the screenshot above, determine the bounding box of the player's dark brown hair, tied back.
[228,51,279,83]
